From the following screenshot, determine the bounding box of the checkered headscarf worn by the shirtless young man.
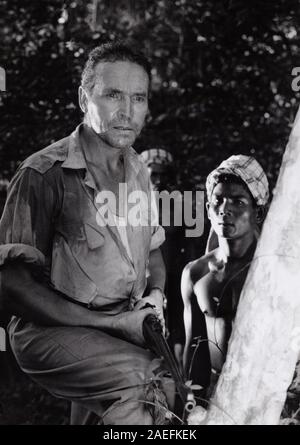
[206,155,269,206]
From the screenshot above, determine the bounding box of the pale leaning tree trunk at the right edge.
[203,110,300,425]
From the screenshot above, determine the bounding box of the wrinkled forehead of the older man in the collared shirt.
[94,60,149,93]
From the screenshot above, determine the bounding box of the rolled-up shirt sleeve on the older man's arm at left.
[0,167,55,266]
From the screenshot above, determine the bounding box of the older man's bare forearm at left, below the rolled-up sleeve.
[1,263,149,345]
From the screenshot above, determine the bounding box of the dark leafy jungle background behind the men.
[0,0,300,424]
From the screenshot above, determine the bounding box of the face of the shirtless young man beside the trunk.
[207,183,257,239]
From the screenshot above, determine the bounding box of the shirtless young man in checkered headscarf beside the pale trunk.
[181,155,269,383]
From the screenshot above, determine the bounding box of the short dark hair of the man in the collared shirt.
[81,42,151,93]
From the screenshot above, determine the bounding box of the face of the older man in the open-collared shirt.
[79,61,149,148]
